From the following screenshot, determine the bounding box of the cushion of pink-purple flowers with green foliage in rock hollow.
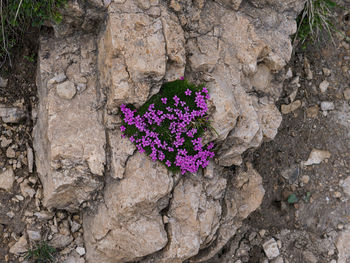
[120,78,214,174]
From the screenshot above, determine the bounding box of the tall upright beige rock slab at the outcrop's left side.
[33,35,106,210]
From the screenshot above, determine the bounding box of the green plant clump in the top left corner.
[0,0,67,67]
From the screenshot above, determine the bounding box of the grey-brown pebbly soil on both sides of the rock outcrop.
[0,4,350,263]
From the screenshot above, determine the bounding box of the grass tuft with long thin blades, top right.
[294,0,337,48]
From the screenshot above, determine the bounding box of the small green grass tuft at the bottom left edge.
[25,242,56,263]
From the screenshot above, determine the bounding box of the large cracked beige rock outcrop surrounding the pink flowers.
[28,0,303,263]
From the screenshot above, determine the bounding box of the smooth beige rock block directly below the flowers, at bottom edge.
[84,153,173,263]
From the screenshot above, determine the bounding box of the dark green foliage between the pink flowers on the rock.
[120,80,216,175]
